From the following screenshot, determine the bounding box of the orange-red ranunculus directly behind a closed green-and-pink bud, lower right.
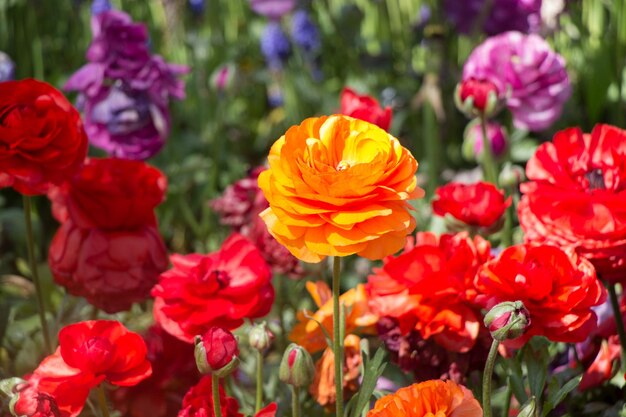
[475,244,606,346]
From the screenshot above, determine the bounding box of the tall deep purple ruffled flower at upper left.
[65,11,188,159]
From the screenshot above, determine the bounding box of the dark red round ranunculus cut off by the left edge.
[0,79,87,195]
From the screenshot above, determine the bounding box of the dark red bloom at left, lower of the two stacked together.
[48,220,168,313]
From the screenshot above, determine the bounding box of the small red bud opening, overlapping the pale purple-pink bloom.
[454,78,502,117]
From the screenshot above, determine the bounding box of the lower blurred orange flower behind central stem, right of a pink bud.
[309,334,362,406]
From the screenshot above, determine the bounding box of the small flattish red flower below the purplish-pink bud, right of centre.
[432,182,511,228]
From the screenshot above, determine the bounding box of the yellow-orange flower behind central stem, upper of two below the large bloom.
[289,281,378,353]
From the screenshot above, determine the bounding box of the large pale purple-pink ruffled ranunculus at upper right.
[463,32,571,130]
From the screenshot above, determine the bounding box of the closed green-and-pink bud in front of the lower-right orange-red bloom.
[485,301,530,342]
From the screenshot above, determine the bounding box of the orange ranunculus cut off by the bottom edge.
[367,380,483,417]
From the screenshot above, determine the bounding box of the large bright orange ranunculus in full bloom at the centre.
[259,115,424,262]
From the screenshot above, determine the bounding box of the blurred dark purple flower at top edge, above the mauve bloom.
[444,0,541,35]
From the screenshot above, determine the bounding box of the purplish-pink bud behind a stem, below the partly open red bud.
[463,119,507,161]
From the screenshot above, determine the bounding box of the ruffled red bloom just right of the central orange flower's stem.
[368,232,490,352]
